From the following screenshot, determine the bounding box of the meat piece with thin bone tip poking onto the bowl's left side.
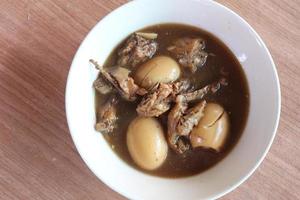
[90,59,147,101]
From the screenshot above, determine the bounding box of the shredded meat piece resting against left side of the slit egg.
[177,100,206,136]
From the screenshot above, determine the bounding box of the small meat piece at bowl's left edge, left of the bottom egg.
[95,96,118,134]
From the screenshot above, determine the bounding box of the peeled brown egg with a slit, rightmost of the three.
[190,103,229,151]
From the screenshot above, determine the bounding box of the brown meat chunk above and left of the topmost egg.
[118,33,158,67]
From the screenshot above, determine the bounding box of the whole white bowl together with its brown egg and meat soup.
[66,0,280,199]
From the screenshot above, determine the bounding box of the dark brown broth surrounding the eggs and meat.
[96,24,249,178]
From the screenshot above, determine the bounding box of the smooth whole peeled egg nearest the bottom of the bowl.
[127,117,168,170]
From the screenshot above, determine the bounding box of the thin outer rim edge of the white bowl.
[65,0,281,199]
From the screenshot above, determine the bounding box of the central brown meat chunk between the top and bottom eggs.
[136,80,189,117]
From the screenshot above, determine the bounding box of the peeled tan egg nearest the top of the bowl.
[134,56,180,88]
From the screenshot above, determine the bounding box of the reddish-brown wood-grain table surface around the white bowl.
[0,0,300,200]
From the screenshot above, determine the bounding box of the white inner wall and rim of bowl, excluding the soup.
[66,0,280,200]
